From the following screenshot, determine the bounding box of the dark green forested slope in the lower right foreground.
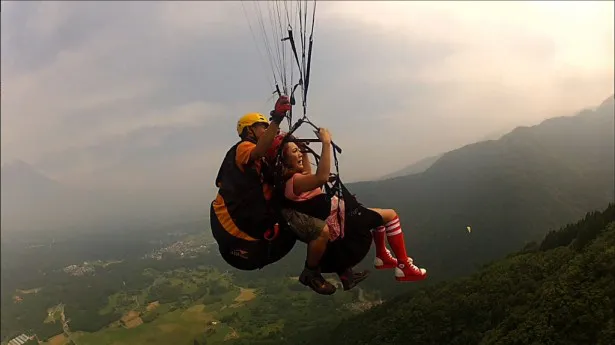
[304,204,615,345]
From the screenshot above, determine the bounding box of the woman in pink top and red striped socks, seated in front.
[267,128,427,285]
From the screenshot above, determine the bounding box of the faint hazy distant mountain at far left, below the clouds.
[0,160,212,235]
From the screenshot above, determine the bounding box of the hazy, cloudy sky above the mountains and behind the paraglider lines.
[0,1,615,203]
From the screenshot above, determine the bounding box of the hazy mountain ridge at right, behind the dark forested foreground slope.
[348,93,615,289]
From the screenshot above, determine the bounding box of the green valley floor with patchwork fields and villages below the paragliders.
[1,227,379,345]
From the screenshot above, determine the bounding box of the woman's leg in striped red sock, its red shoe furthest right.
[371,208,427,281]
